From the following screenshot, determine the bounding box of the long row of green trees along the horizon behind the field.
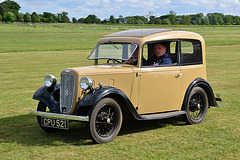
[0,0,240,25]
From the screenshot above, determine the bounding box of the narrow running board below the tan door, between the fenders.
[140,111,186,120]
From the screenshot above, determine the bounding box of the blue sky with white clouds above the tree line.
[0,0,240,20]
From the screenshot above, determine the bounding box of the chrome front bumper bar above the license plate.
[29,109,89,122]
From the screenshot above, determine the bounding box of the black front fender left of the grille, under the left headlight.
[33,83,60,113]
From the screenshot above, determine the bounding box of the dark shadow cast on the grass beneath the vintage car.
[0,115,185,146]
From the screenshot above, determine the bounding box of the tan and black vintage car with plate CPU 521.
[30,29,221,143]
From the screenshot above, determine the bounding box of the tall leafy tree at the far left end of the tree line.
[0,0,21,15]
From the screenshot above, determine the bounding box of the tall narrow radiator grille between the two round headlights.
[60,74,76,113]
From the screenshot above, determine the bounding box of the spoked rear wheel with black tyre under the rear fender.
[184,87,208,124]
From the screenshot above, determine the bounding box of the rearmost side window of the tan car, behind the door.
[181,40,202,65]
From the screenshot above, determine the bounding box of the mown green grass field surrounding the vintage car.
[0,24,240,160]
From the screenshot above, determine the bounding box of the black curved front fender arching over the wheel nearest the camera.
[79,87,142,120]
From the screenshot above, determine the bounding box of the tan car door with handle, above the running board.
[138,42,180,114]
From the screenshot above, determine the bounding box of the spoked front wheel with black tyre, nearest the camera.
[86,98,123,143]
